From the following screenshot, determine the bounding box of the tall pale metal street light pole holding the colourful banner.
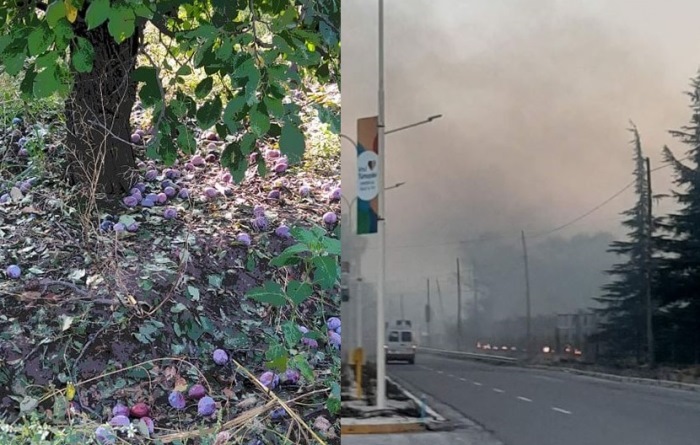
[376,0,386,409]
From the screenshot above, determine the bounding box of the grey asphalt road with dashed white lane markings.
[387,354,700,445]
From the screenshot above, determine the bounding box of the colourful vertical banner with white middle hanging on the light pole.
[357,116,381,235]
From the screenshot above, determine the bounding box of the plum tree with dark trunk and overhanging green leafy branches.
[0,0,340,195]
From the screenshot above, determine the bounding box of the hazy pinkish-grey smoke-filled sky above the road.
[341,0,700,332]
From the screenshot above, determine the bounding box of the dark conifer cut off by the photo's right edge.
[659,73,700,363]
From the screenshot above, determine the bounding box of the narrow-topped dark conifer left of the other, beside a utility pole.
[594,124,649,362]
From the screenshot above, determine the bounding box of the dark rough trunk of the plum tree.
[66,19,143,197]
